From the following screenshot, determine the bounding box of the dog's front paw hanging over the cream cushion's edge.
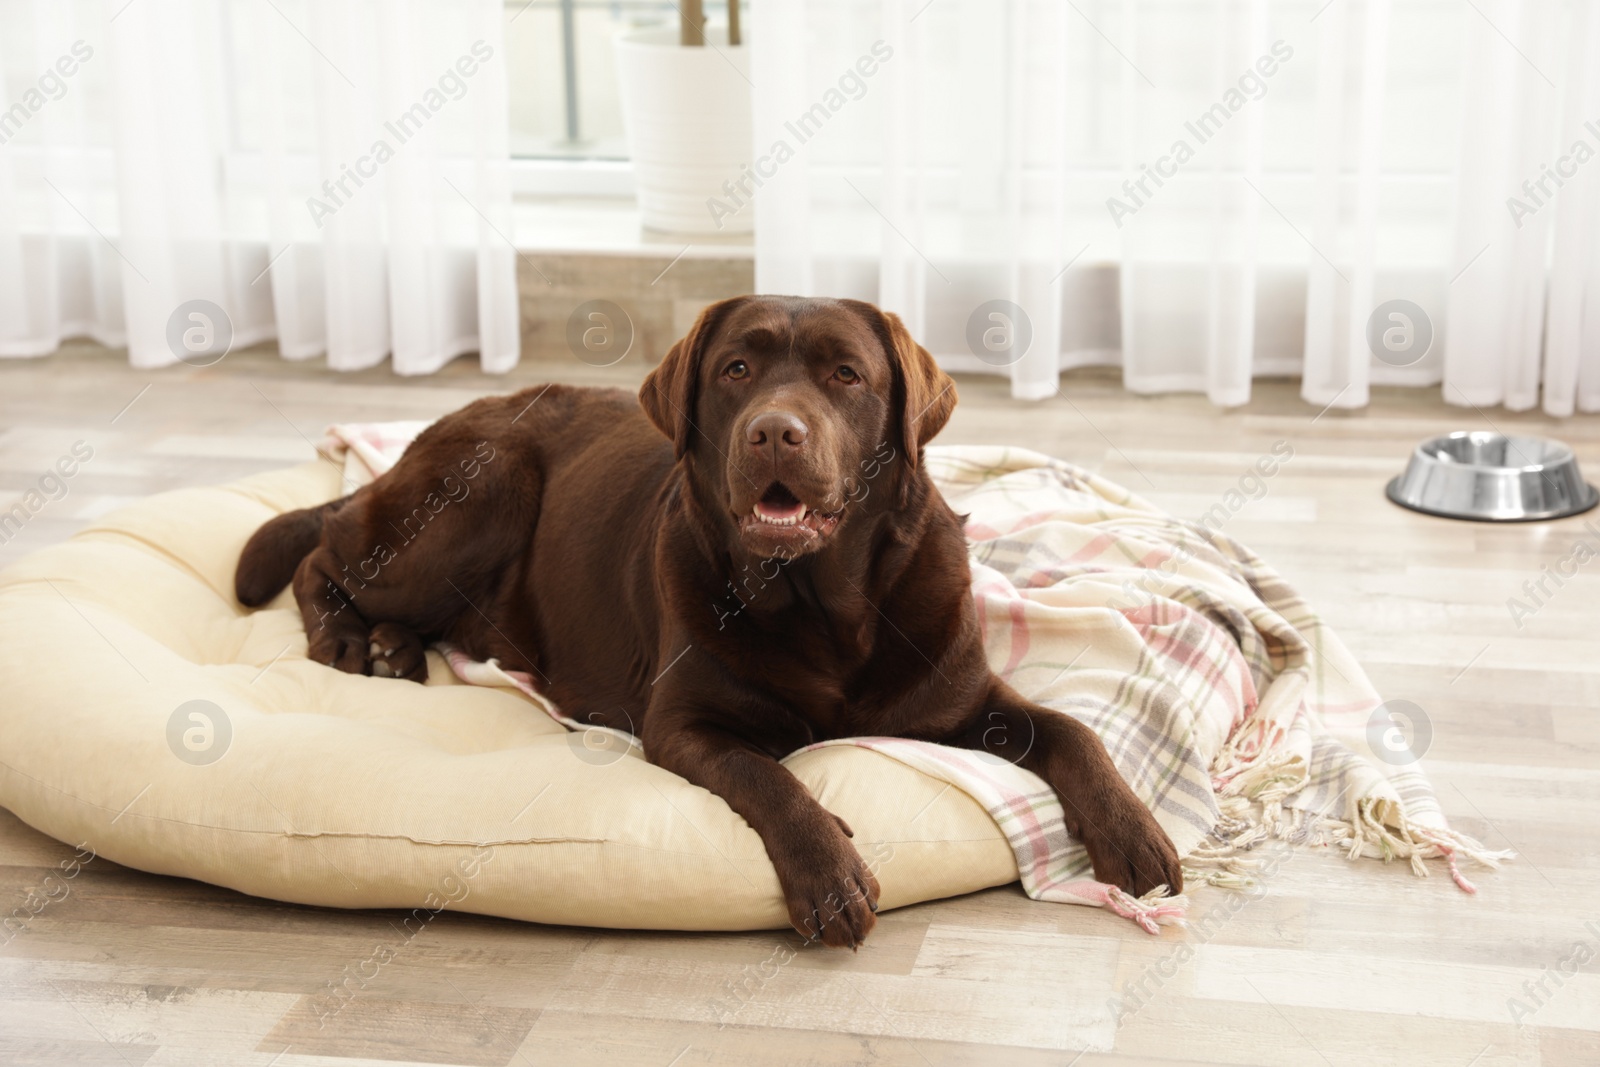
[774,821,878,949]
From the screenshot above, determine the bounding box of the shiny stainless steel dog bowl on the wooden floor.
[1387,430,1600,523]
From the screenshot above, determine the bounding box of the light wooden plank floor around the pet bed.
[0,347,1600,1067]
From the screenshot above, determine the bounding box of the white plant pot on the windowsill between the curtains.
[616,26,755,234]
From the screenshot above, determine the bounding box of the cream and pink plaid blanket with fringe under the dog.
[326,422,1509,933]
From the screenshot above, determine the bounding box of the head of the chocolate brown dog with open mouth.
[640,296,955,558]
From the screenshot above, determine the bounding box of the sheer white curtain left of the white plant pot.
[0,0,518,374]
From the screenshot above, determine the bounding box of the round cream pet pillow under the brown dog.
[0,462,1018,929]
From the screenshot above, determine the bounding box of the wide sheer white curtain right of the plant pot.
[750,0,1600,414]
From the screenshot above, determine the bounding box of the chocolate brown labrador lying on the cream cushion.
[235,296,1182,947]
